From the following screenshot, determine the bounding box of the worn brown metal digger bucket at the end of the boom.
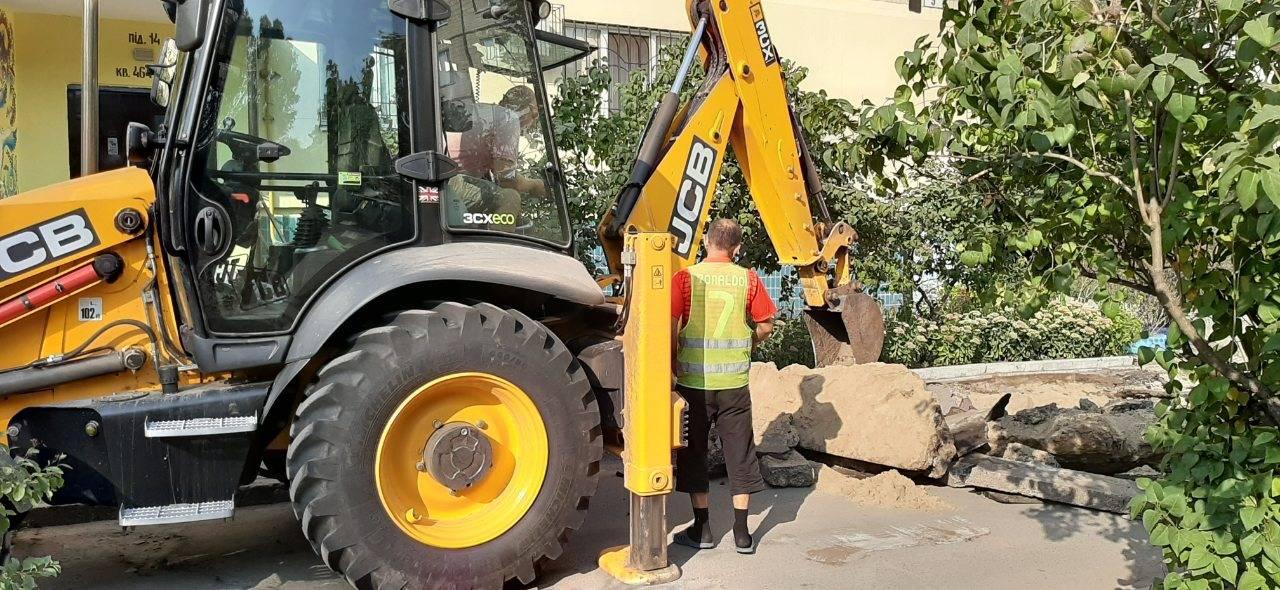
[805,285,884,367]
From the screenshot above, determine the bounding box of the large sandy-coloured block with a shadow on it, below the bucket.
[751,363,956,477]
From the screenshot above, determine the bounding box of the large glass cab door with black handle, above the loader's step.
[178,0,414,337]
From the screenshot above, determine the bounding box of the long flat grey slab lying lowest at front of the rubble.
[947,454,1138,514]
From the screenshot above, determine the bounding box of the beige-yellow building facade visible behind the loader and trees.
[0,0,941,197]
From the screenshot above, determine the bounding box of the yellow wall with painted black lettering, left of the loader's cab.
[10,13,173,191]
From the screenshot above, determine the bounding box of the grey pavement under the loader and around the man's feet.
[17,462,1162,590]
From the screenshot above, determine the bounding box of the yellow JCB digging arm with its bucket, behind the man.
[600,0,884,365]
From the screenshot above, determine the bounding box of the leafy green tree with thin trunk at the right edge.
[849,0,1280,589]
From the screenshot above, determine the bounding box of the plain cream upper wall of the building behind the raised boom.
[553,0,942,102]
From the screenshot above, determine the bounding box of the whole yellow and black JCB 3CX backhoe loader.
[0,0,882,589]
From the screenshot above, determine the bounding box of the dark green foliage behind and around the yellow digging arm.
[554,47,1023,312]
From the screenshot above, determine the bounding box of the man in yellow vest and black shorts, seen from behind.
[672,219,777,553]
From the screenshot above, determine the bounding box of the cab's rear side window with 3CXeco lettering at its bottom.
[436,0,570,246]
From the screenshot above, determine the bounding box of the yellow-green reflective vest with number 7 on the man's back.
[677,262,753,390]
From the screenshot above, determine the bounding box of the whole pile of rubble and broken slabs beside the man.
[710,355,1167,511]
